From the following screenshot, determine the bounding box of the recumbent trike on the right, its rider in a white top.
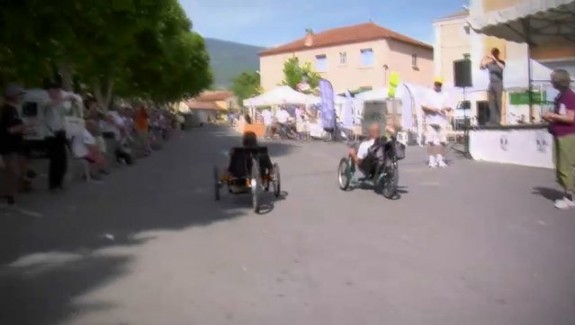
[337,136,405,199]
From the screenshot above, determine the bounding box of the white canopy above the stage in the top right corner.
[469,0,575,45]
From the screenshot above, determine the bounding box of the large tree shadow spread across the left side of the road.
[0,127,296,325]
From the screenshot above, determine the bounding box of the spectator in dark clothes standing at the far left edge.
[0,85,27,205]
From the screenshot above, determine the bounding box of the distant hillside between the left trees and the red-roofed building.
[205,38,263,89]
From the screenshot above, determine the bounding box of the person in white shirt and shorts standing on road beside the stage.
[421,78,451,168]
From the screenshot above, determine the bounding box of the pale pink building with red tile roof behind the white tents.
[260,22,433,92]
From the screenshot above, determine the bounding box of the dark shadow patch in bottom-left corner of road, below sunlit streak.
[0,256,131,324]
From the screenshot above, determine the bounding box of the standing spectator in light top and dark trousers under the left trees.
[44,84,70,191]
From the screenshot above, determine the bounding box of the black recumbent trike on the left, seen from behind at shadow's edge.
[214,146,281,213]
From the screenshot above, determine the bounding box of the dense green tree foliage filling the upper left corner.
[0,0,211,106]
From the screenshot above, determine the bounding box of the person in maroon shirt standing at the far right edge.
[543,69,575,210]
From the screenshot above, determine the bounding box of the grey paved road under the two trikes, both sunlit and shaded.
[0,128,575,325]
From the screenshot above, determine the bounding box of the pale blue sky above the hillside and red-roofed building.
[180,0,468,47]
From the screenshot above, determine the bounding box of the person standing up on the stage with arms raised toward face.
[480,48,505,125]
